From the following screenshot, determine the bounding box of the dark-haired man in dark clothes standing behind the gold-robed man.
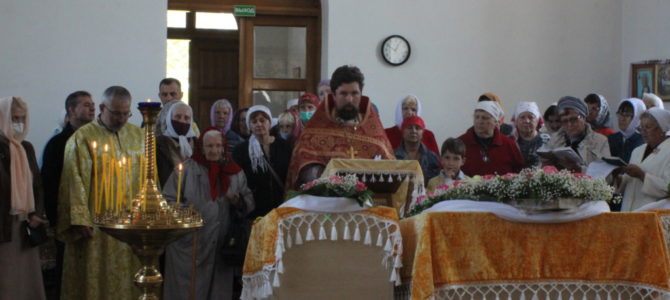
[41,91,95,298]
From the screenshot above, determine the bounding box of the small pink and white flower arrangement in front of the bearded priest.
[287,174,372,206]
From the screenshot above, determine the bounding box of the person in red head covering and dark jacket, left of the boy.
[395,116,440,183]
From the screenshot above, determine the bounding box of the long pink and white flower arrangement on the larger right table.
[410,166,614,215]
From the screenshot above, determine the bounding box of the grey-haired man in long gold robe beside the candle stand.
[57,86,144,300]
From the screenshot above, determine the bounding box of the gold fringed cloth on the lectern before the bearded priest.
[321,158,424,216]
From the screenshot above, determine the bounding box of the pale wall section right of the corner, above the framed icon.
[620,0,670,99]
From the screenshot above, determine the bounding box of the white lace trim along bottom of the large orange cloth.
[394,281,670,300]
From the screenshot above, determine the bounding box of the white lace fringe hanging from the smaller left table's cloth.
[242,212,402,299]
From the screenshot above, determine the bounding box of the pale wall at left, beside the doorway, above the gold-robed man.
[0,0,167,159]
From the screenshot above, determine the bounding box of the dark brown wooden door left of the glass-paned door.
[189,32,239,129]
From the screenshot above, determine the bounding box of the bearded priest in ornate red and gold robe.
[286,65,395,189]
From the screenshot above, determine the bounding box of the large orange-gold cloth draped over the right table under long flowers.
[400,212,670,299]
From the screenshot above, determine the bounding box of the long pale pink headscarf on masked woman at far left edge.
[0,97,35,219]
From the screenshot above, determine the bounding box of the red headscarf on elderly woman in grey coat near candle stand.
[191,127,242,201]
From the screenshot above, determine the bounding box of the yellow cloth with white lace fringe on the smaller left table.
[242,206,402,299]
